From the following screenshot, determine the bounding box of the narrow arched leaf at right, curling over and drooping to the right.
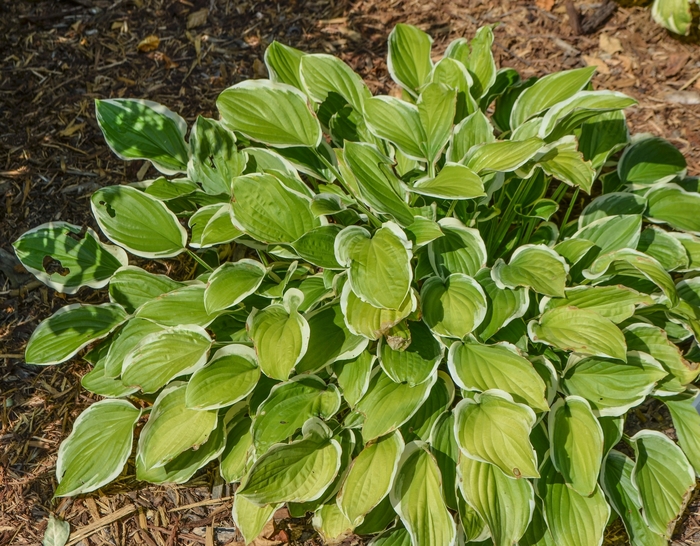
[583,248,678,306]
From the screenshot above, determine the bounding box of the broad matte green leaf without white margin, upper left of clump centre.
[233,174,321,243]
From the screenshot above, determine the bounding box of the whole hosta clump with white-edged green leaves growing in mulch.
[15,25,700,546]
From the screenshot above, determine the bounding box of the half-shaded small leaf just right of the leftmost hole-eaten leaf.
[109,266,184,313]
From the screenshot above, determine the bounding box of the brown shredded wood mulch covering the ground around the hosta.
[0,0,700,546]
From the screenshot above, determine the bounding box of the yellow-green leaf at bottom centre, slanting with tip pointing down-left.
[337,431,404,526]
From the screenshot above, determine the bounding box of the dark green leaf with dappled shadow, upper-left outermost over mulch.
[95,99,188,174]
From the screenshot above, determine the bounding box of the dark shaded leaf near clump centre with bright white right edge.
[296,305,369,373]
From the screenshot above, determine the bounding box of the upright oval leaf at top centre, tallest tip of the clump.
[387,23,433,96]
